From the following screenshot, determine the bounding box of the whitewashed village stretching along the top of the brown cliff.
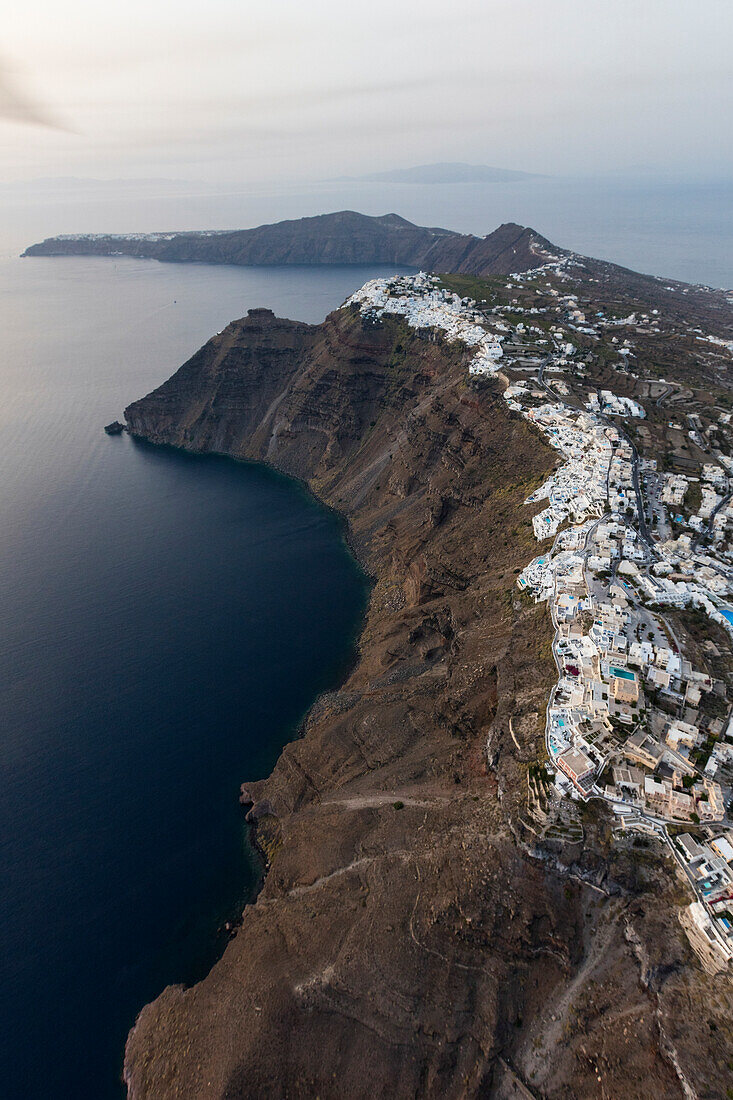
[349,270,733,971]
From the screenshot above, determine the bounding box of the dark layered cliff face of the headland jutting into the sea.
[125,309,400,480]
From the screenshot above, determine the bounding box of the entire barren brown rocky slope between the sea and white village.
[125,308,733,1100]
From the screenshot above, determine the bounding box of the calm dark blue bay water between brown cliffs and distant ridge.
[0,260,411,1100]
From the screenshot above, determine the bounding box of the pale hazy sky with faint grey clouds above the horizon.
[0,0,733,182]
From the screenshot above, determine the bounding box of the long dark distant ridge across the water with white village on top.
[23,210,565,275]
